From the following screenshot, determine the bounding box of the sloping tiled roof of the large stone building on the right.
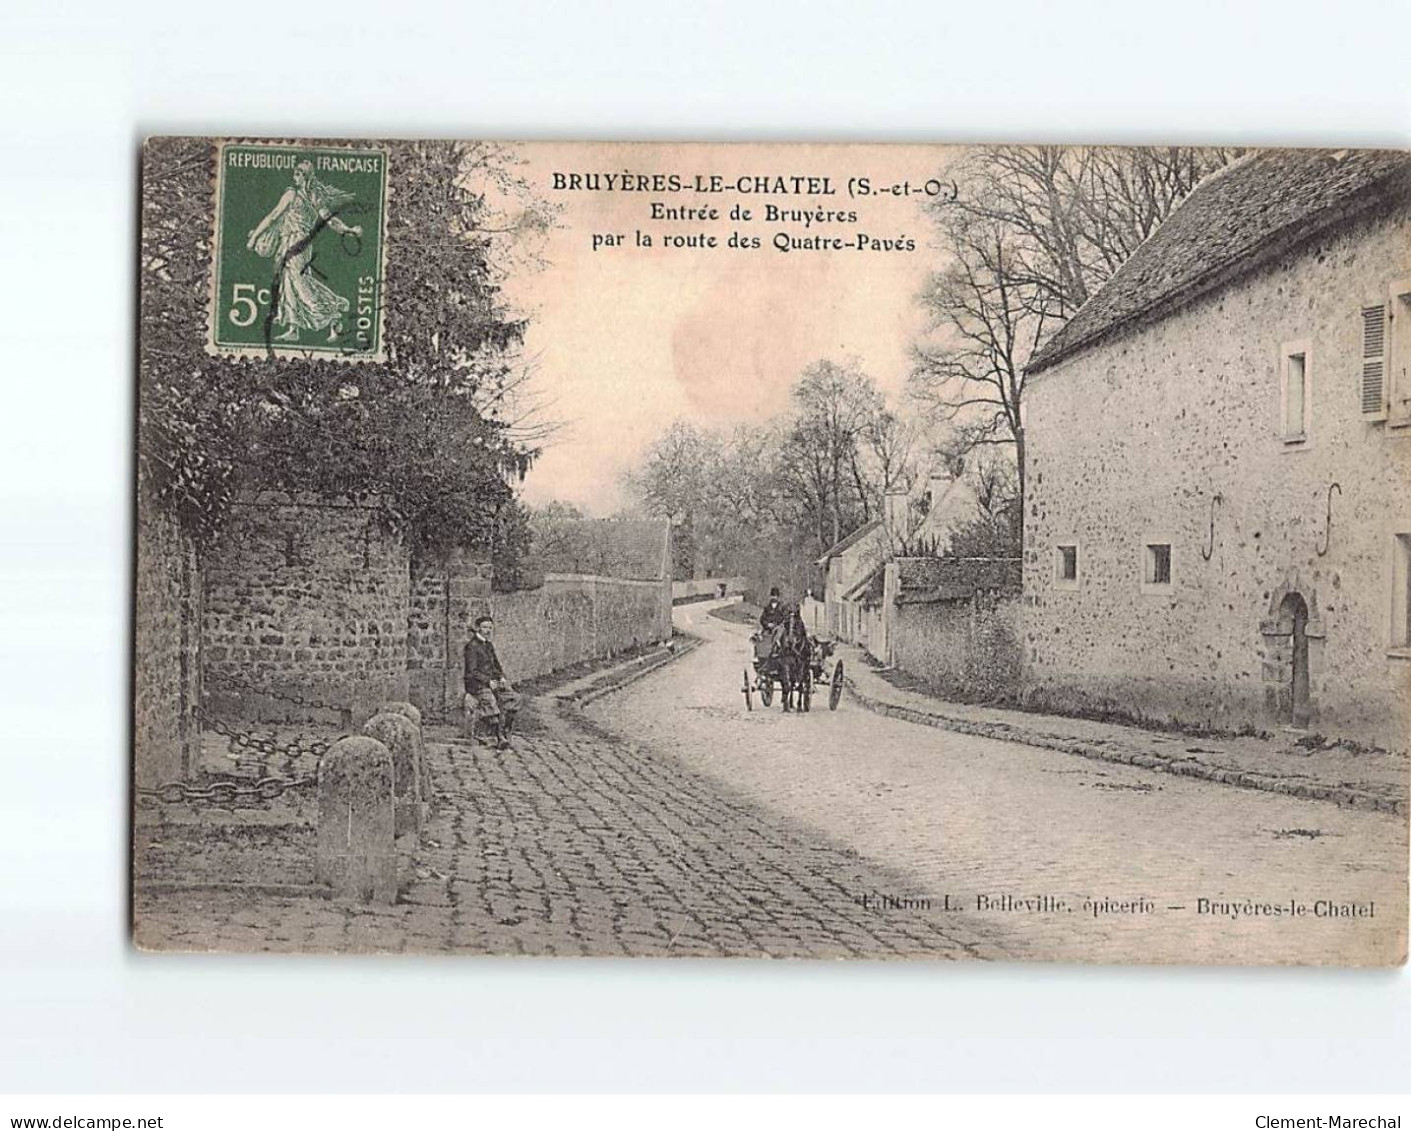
[1027,149,1411,372]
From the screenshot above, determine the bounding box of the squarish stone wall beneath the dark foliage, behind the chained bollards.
[203,496,409,723]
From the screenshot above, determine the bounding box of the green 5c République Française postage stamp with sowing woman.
[209,141,387,361]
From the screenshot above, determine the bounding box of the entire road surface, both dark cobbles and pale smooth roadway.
[134,606,1407,962]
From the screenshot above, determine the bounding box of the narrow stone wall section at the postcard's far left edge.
[133,505,200,787]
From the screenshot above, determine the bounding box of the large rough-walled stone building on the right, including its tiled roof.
[1023,149,1411,749]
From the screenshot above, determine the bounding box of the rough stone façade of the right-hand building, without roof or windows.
[1023,209,1411,749]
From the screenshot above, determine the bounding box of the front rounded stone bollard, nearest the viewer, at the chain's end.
[315,736,396,904]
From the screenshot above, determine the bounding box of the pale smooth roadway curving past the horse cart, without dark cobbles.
[588,606,1407,962]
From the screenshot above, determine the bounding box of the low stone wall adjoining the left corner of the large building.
[888,589,1023,701]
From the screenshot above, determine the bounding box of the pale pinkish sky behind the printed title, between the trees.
[507,144,958,516]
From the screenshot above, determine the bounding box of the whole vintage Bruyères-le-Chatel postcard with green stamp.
[131,137,1411,966]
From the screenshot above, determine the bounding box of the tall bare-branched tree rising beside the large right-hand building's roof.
[912,145,1237,499]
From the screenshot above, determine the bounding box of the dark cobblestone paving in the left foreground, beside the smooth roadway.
[134,705,1002,958]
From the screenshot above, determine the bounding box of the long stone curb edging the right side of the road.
[844,675,1407,817]
